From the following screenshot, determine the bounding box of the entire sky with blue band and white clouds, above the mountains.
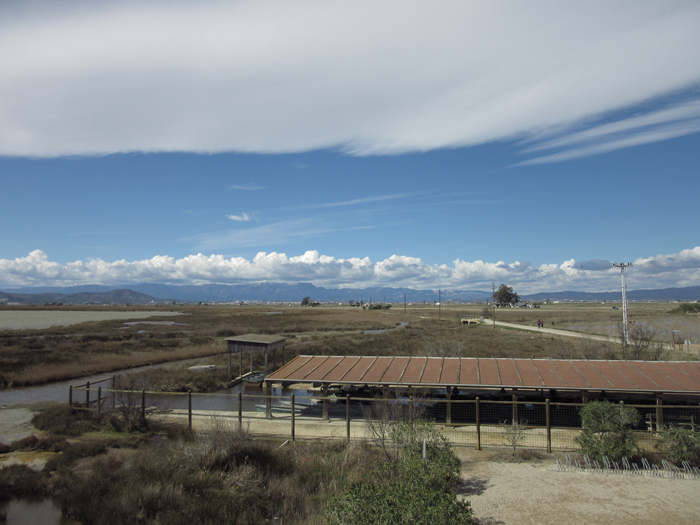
[0,1,700,293]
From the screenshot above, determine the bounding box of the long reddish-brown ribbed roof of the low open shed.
[267,355,700,393]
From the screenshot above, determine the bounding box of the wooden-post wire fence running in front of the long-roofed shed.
[69,383,700,452]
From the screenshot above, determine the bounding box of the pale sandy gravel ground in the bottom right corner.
[462,452,700,525]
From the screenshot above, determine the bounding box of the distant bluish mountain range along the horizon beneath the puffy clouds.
[0,283,700,305]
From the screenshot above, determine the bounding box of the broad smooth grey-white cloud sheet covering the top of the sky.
[0,0,700,160]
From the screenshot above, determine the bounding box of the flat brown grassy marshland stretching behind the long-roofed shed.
[0,303,697,387]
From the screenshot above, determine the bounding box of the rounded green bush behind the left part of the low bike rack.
[574,401,640,461]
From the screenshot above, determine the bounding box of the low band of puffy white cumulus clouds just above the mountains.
[0,246,700,293]
